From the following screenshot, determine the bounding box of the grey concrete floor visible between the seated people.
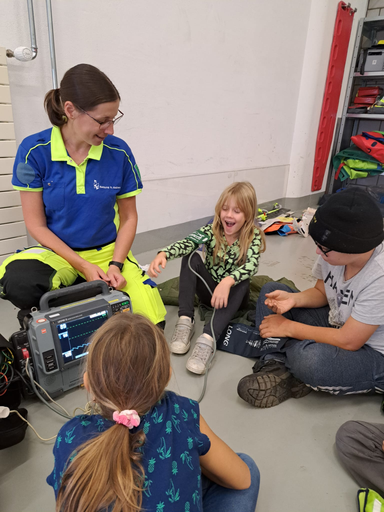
[0,235,383,512]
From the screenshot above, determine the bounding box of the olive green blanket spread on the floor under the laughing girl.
[158,276,298,325]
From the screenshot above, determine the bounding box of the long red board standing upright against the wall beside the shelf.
[311,2,355,192]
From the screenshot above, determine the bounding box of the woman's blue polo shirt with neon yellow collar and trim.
[12,126,143,249]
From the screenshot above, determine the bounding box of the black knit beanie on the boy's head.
[309,187,384,254]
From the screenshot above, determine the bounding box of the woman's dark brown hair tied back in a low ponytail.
[44,64,120,126]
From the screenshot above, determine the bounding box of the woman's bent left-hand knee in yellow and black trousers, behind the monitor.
[0,246,78,309]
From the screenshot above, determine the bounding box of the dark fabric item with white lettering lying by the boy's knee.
[217,323,289,357]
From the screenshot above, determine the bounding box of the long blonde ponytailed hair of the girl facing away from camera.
[56,313,170,512]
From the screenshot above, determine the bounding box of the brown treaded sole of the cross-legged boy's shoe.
[237,372,298,409]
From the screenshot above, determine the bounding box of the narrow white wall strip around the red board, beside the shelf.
[286,0,368,197]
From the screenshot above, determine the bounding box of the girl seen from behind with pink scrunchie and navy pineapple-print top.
[47,313,260,512]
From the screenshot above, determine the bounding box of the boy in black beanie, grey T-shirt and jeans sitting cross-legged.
[238,187,384,407]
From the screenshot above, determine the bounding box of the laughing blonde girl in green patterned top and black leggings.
[148,181,265,374]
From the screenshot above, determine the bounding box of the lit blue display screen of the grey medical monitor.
[56,309,108,364]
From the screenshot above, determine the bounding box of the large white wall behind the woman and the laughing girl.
[0,0,366,232]
